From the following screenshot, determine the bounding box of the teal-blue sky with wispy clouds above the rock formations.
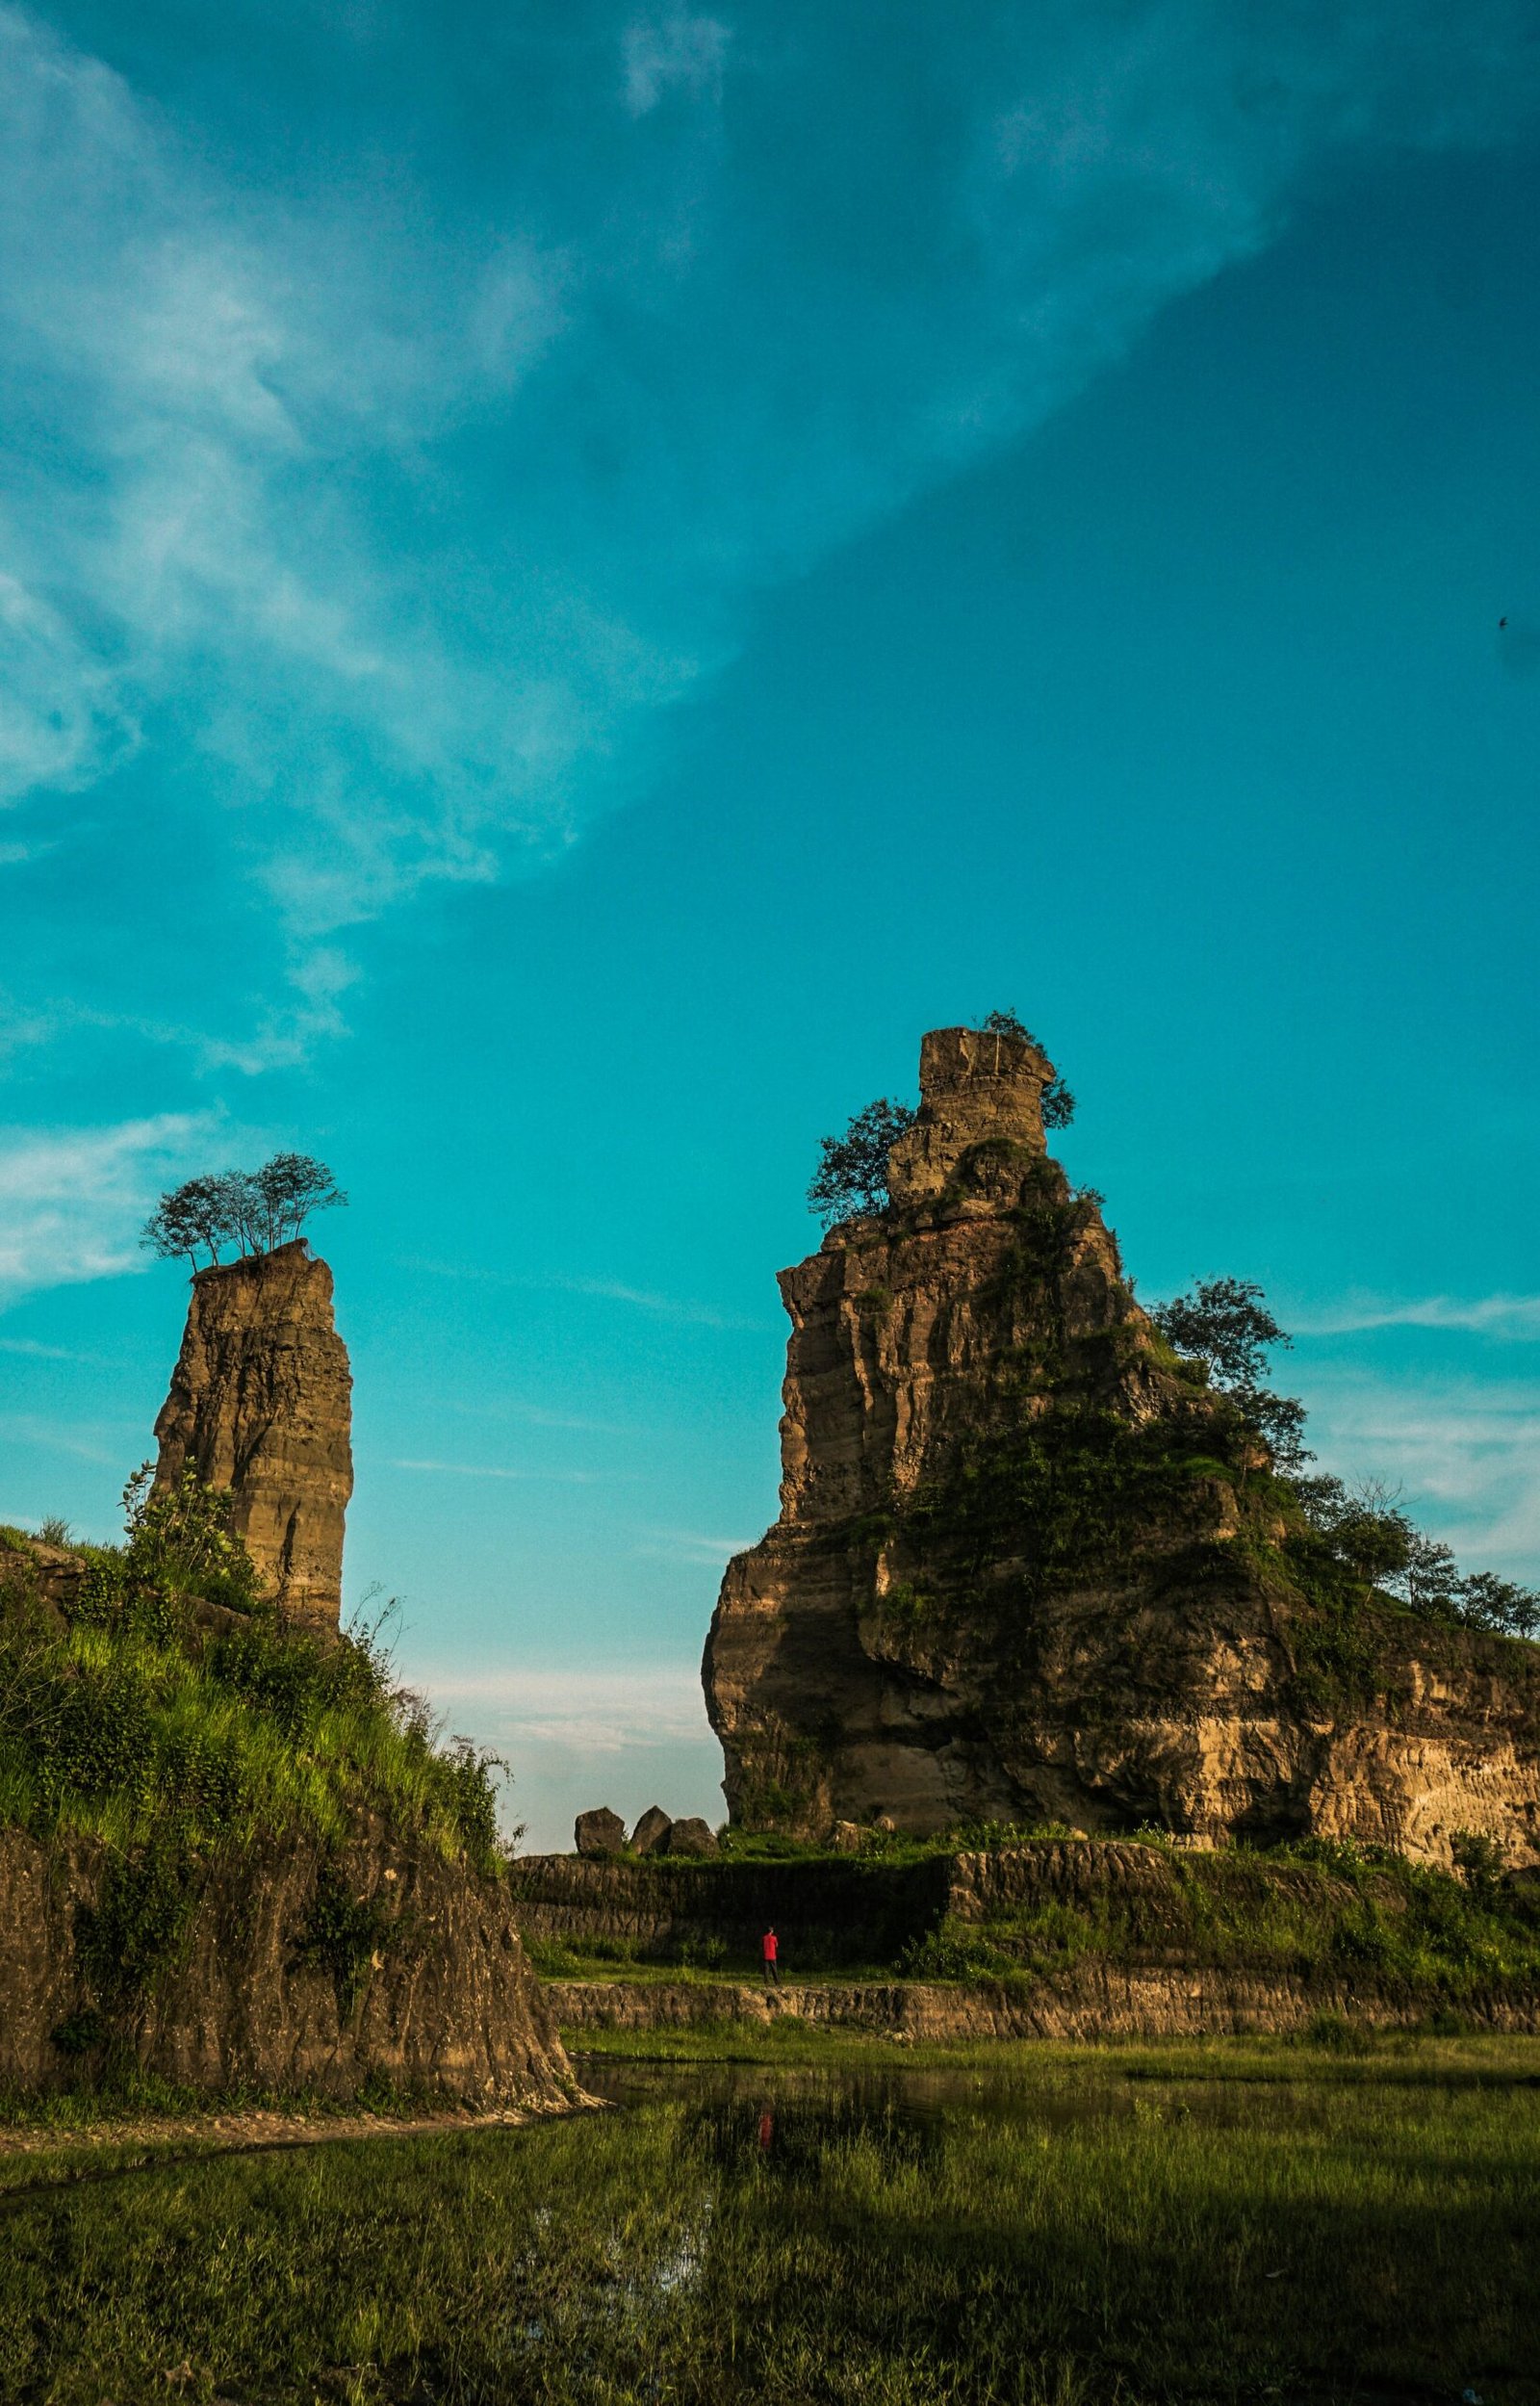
[0,0,1540,1843]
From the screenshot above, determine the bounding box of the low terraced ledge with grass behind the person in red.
[513,1838,1540,2040]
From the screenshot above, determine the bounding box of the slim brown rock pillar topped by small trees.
[154,1236,354,1626]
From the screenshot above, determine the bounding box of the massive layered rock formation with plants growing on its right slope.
[703,1027,1540,1862]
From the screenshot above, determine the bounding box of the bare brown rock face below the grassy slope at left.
[0,1826,573,2106]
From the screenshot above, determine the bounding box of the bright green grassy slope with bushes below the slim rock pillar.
[0,1482,499,1870]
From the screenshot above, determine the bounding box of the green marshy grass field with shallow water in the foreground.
[0,2033,1540,2406]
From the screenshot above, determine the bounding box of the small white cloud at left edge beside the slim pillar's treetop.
[0,1112,219,1299]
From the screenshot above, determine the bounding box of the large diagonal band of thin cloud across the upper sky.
[0,0,1540,1071]
